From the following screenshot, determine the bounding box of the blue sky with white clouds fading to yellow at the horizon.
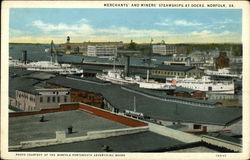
[9,8,242,43]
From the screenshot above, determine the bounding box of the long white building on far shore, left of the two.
[87,46,117,57]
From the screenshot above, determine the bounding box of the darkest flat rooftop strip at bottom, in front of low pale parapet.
[22,131,184,152]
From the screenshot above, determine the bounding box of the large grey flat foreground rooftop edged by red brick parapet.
[9,110,128,145]
